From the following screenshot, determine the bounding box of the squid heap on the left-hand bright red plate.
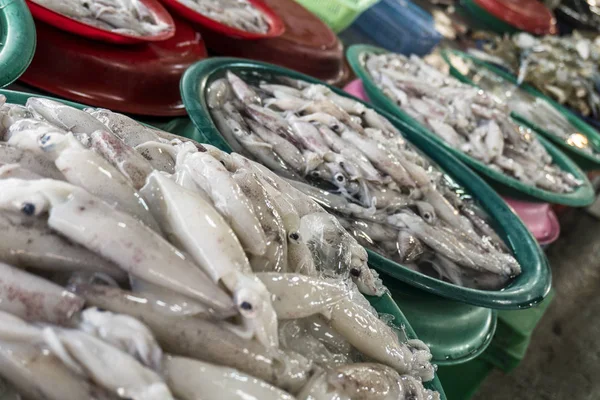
[31,0,171,36]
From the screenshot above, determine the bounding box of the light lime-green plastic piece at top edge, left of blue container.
[296,0,379,33]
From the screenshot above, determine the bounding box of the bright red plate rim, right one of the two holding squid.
[161,0,285,39]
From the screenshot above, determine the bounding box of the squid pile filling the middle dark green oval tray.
[206,71,521,289]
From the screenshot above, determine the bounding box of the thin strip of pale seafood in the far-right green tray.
[442,54,600,157]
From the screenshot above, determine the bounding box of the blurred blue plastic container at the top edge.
[342,0,442,56]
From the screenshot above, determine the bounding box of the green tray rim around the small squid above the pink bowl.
[347,45,595,207]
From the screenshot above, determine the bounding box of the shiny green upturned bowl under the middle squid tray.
[380,274,498,366]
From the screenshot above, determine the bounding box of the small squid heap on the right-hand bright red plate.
[177,0,269,33]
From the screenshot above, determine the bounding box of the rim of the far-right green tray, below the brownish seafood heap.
[442,50,600,170]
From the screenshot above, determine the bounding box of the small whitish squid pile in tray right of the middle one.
[362,53,582,193]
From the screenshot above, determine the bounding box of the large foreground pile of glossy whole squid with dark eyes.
[0,97,439,400]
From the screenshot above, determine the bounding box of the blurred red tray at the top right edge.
[474,0,557,35]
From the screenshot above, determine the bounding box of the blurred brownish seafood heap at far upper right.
[484,32,600,118]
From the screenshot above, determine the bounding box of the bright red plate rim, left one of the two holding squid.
[27,0,175,44]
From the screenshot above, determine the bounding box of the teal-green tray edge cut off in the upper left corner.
[0,0,36,87]
